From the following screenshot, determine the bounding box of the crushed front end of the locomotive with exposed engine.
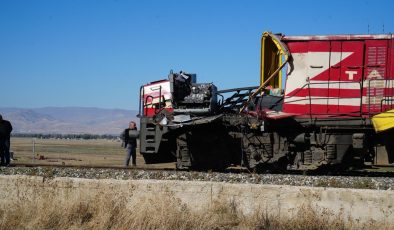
[140,71,231,169]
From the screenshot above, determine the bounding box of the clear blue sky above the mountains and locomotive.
[0,0,394,109]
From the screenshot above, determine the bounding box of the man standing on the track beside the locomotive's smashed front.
[121,121,139,167]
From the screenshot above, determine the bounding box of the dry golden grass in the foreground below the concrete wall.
[0,190,392,230]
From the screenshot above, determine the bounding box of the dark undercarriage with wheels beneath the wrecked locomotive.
[144,114,376,171]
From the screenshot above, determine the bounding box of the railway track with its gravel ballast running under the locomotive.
[0,164,394,190]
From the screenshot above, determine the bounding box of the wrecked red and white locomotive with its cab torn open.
[140,32,394,170]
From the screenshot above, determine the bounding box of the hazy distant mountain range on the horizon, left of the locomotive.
[0,107,139,135]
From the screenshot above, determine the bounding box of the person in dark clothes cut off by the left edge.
[0,115,12,166]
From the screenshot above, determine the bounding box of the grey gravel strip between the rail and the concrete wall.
[0,167,394,190]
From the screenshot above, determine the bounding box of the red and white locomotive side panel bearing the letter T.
[283,40,364,118]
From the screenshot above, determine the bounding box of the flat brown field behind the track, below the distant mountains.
[11,137,175,168]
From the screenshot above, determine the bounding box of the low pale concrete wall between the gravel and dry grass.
[0,175,394,224]
